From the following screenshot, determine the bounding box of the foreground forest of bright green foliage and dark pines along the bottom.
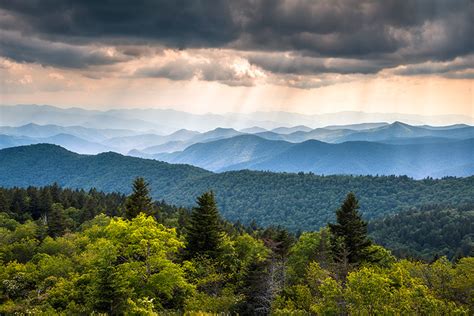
[0,178,474,315]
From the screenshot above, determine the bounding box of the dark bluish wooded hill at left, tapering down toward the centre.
[0,144,211,192]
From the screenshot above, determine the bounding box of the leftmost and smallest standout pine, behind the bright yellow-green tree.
[125,177,153,219]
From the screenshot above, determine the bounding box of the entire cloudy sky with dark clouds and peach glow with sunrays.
[0,0,474,117]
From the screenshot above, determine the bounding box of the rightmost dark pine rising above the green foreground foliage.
[329,192,371,264]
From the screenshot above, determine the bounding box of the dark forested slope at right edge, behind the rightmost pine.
[369,204,474,260]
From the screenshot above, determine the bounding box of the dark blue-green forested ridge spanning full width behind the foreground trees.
[0,144,474,232]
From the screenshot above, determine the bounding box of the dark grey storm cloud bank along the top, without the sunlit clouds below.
[0,0,474,80]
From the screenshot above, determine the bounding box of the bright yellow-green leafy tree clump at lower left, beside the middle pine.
[0,214,194,314]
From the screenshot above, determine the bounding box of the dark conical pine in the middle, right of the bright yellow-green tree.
[186,191,222,258]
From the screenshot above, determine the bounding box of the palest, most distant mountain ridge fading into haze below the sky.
[0,105,474,135]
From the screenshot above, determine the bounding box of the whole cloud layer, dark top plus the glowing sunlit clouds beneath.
[0,0,474,88]
